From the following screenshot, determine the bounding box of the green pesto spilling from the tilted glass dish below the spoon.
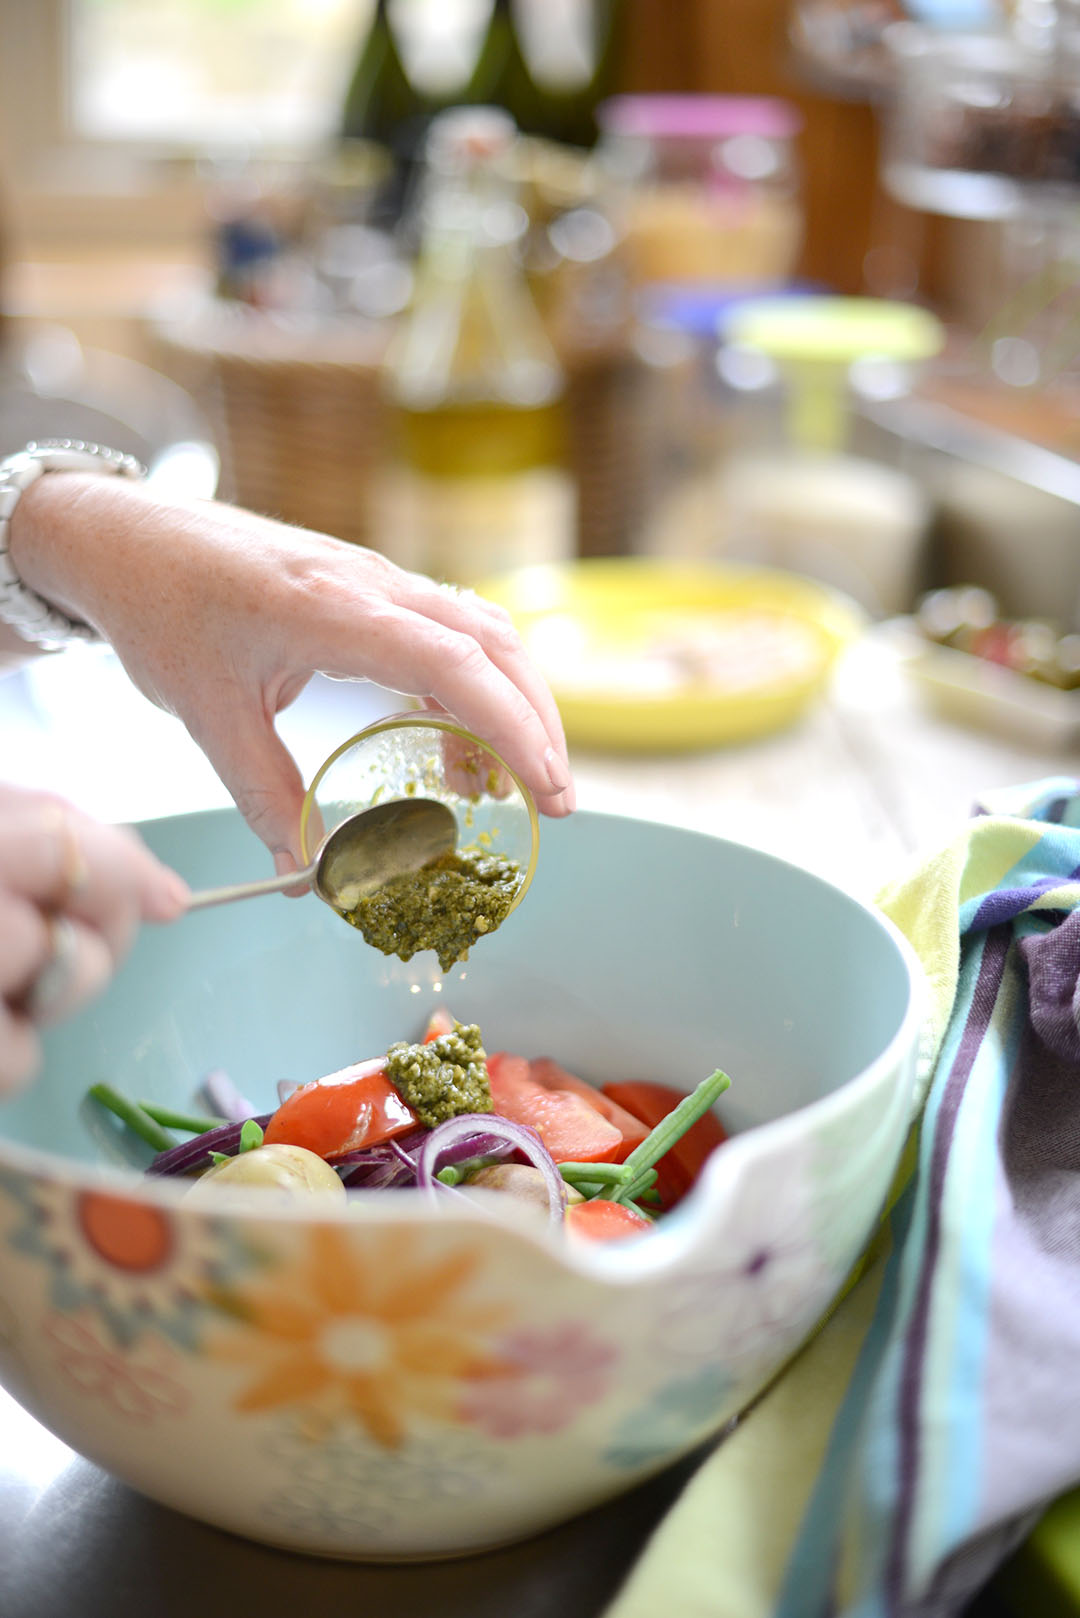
[343,848,521,972]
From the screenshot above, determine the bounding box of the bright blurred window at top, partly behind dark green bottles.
[52,0,589,149]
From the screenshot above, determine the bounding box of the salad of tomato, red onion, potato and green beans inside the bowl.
[89,1008,730,1241]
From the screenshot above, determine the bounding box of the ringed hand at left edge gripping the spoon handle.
[0,785,188,1094]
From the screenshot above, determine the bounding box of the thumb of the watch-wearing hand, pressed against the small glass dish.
[191,709,304,875]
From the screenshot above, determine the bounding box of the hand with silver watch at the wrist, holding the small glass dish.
[11,472,575,872]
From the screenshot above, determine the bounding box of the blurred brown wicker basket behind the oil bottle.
[154,306,630,560]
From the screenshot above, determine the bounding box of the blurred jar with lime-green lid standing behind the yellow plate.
[716,294,944,616]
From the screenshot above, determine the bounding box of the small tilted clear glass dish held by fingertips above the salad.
[300,712,539,914]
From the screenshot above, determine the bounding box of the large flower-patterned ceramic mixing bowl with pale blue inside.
[0,811,920,1558]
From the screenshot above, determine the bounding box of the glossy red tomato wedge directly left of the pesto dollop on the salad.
[262,1057,419,1157]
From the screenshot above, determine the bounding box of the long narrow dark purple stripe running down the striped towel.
[886,927,1012,1613]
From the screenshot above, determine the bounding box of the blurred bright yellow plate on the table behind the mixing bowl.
[481,557,865,752]
